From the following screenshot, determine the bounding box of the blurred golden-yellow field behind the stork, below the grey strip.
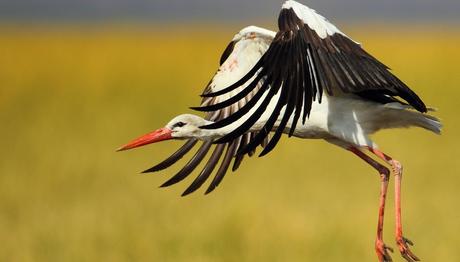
[0,25,460,261]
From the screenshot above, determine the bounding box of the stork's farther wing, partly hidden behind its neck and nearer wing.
[144,27,275,196]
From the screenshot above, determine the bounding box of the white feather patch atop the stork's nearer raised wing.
[283,0,346,39]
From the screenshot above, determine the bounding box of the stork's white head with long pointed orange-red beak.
[118,114,210,151]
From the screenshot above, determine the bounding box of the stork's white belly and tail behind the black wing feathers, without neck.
[285,95,440,148]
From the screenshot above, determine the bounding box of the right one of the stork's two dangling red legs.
[369,148,420,262]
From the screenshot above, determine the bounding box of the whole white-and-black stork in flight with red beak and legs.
[119,0,442,262]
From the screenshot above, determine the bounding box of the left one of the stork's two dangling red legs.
[349,147,393,262]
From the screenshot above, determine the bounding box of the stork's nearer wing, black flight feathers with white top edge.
[194,1,426,158]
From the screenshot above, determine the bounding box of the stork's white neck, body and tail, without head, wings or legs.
[183,95,441,148]
